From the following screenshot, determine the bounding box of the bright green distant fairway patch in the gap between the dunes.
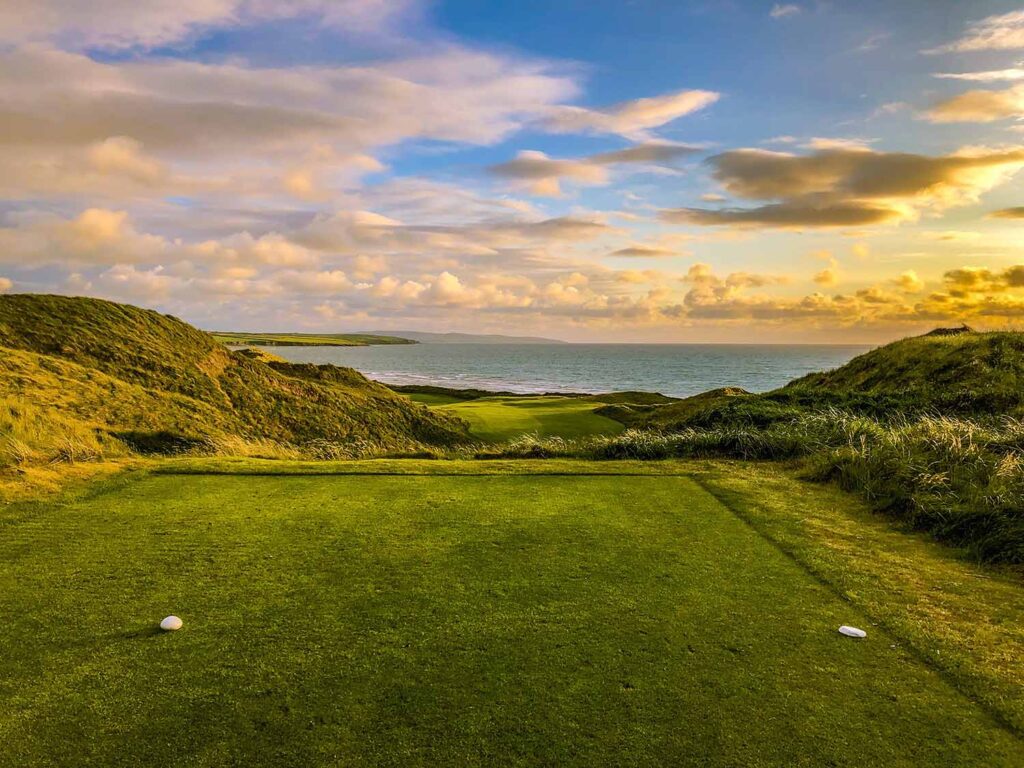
[428,396,624,442]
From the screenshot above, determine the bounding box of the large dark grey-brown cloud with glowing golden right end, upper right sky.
[660,148,1024,228]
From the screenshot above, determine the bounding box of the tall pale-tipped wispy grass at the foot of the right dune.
[456,410,1024,565]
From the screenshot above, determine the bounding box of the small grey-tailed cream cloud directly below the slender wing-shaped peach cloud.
[487,142,697,198]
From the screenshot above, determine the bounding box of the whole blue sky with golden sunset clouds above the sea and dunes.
[0,0,1024,343]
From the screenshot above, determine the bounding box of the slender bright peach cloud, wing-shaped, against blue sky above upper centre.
[544,90,721,139]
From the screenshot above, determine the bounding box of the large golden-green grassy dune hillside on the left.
[0,294,465,463]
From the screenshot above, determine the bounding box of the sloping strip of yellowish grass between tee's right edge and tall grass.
[697,462,1024,732]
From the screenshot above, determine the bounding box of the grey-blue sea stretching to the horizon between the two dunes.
[256,344,871,397]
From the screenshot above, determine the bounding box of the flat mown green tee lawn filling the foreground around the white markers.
[6,461,1024,767]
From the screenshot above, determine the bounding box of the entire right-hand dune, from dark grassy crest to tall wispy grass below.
[593,332,1024,564]
